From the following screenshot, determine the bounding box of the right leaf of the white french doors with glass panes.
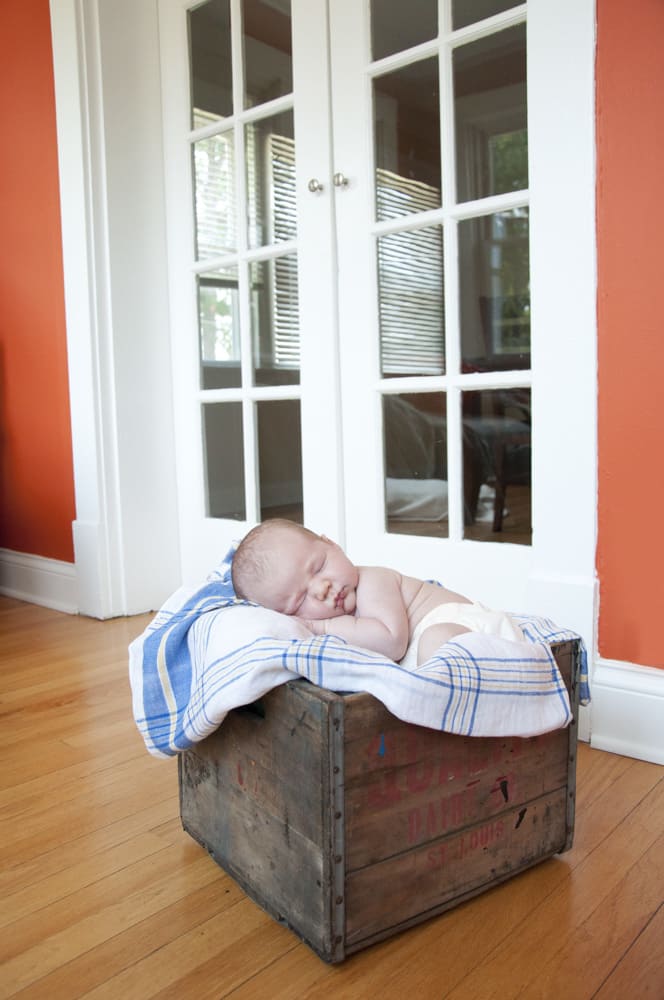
[330,0,532,606]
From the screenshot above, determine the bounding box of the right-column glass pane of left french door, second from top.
[244,111,297,249]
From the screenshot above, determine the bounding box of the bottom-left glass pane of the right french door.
[383,392,448,538]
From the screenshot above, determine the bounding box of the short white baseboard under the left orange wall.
[0,549,78,615]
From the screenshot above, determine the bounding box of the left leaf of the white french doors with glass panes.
[159,0,344,580]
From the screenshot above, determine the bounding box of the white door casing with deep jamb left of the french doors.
[50,0,180,618]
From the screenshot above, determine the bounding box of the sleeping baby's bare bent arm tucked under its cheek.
[305,566,408,660]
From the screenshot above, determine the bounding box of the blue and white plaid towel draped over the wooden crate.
[129,549,589,757]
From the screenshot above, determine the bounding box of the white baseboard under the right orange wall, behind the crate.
[590,659,664,764]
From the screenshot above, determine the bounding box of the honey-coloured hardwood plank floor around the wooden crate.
[0,598,664,1000]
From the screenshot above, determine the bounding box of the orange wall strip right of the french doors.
[597,0,664,667]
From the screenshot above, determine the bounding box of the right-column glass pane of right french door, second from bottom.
[459,208,530,371]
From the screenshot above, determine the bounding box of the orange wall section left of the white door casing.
[0,0,74,562]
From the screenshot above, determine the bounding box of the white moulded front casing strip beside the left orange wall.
[50,0,124,618]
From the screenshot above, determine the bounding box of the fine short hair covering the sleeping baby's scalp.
[231,517,319,607]
